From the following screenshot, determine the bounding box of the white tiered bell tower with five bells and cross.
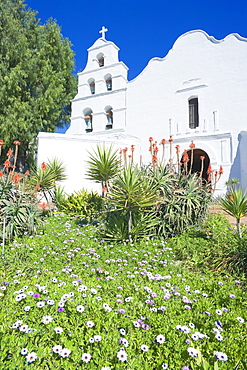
[66,27,128,135]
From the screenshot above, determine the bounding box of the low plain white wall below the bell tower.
[38,130,140,194]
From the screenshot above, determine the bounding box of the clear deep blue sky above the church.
[25,0,247,80]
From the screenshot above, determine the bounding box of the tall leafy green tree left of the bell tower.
[0,0,76,166]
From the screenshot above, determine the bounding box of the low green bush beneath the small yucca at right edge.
[169,214,247,276]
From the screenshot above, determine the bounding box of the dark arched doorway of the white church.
[182,149,210,181]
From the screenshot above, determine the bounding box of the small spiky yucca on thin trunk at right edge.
[220,188,247,238]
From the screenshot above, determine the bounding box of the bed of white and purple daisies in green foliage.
[0,216,247,370]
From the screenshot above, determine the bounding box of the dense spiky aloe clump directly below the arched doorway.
[147,166,211,237]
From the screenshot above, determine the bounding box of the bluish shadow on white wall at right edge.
[228,131,247,189]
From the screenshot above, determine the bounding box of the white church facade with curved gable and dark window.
[126,31,247,192]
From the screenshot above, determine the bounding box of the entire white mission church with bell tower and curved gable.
[38,27,247,193]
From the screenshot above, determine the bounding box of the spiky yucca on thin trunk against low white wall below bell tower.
[86,145,120,197]
